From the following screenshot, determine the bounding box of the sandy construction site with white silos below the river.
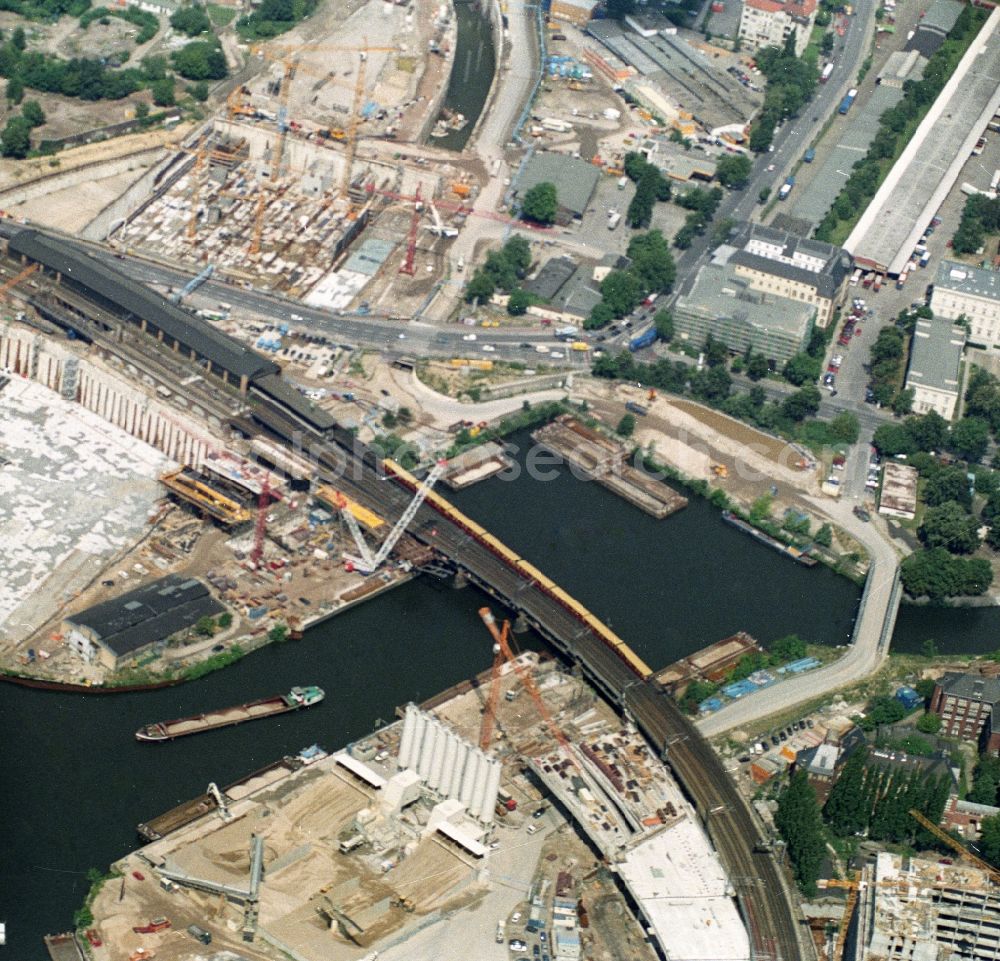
[93,608,749,961]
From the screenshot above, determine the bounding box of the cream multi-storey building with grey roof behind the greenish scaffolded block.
[720,223,851,327]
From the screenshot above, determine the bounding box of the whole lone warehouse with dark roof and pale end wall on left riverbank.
[62,574,225,670]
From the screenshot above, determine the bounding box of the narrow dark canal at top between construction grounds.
[428,0,496,150]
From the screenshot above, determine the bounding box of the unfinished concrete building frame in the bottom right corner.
[848,853,1000,961]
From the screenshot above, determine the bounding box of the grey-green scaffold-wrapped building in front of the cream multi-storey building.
[673,250,816,365]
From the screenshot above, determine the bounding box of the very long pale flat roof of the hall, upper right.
[844,8,1000,276]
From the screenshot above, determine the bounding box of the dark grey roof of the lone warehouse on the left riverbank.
[66,574,225,657]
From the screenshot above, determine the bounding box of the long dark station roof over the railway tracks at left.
[10,230,280,380]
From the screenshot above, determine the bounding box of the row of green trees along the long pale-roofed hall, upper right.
[816,6,988,248]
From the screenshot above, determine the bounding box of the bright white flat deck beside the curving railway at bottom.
[618,818,750,961]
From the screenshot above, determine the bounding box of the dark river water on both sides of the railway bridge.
[0,436,1000,961]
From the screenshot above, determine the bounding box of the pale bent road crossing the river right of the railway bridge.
[697,498,899,737]
